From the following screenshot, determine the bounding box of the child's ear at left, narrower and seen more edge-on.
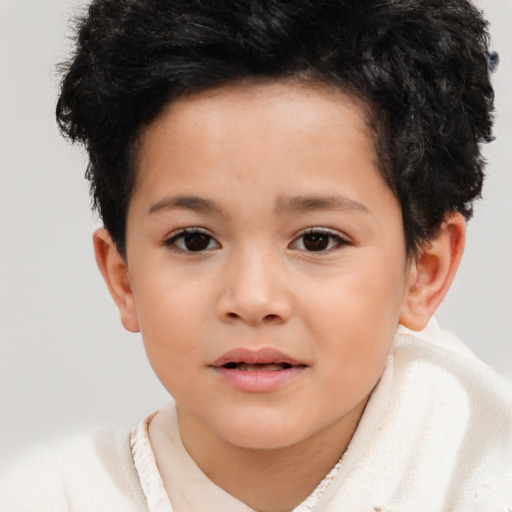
[93,228,140,332]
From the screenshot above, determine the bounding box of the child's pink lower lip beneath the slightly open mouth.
[212,366,306,393]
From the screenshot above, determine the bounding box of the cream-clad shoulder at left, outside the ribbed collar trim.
[0,430,147,512]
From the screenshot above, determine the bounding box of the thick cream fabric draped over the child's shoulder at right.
[326,322,512,512]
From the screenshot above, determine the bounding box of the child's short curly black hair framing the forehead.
[57,0,494,255]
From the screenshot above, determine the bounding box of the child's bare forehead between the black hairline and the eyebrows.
[132,81,392,218]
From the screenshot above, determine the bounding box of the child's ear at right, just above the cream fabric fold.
[400,213,466,331]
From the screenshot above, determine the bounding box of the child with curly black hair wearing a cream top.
[0,0,512,512]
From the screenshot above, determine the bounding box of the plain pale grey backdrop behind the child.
[0,0,512,460]
